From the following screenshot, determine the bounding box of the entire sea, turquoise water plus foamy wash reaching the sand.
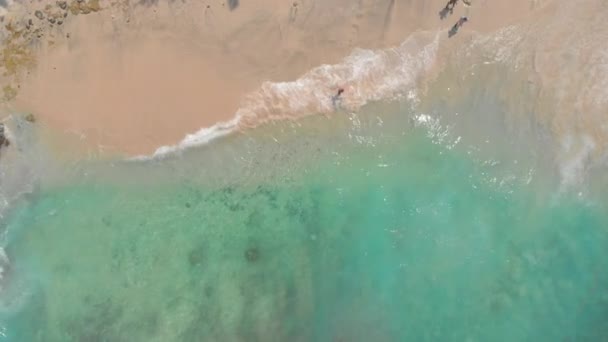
[0,0,608,342]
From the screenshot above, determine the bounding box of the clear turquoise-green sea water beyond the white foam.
[2,100,608,341]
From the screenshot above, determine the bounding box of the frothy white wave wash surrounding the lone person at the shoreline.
[137,32,440,160]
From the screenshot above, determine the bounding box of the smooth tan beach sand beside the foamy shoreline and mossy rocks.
[4,0,550,154]
